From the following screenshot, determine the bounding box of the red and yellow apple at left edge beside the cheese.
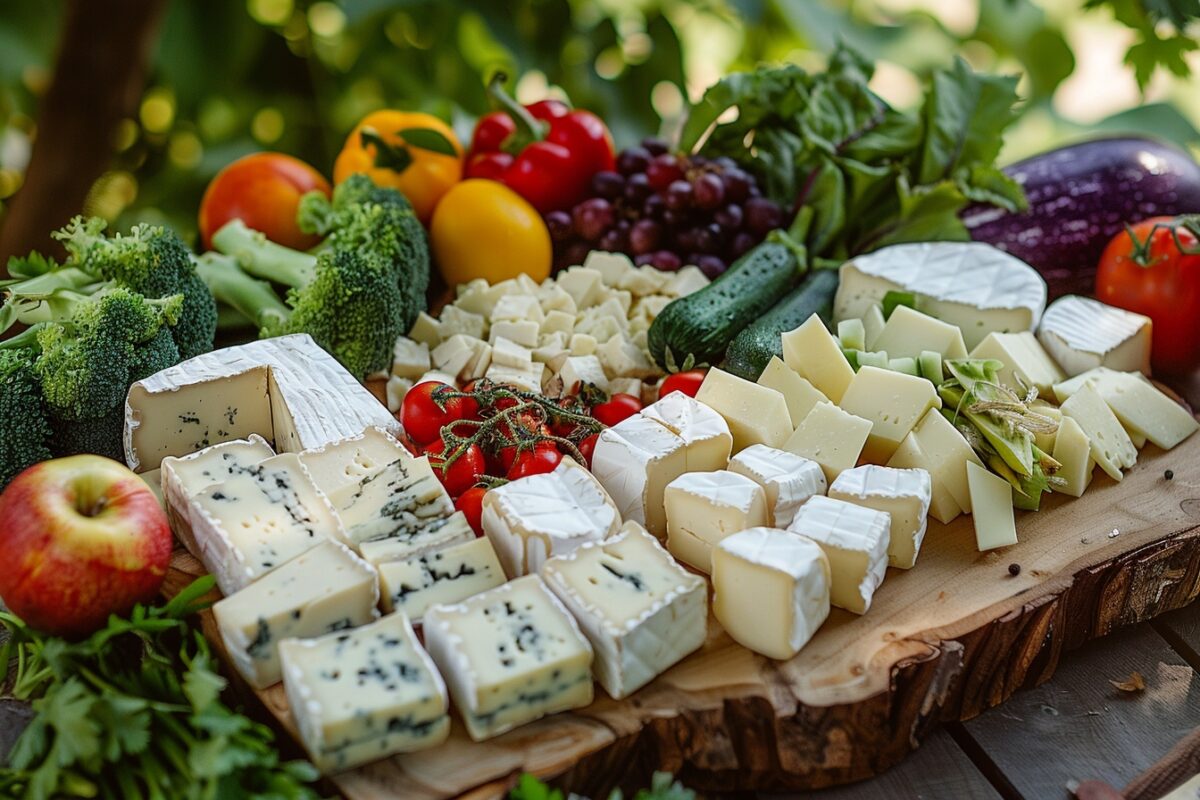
[0,456,172,637]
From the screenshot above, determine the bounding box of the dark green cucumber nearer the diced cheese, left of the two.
[647,234,802,379]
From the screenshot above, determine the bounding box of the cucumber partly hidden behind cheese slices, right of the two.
[715,270,838,380]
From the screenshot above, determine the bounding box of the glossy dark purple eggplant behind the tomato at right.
[962,137,1200,299]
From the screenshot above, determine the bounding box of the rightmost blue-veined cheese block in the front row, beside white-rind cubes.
[541,522,708,699]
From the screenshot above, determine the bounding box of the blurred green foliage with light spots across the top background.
[0,0,1200,247]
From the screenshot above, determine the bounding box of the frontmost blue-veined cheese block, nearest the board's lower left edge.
[280,614,450,772]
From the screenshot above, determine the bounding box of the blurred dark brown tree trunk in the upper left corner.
[0,0,167,271]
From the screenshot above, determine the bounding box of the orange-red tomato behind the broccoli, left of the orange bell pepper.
[199,152,330,249]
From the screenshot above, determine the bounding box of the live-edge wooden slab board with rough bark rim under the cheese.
[168,435,1200,800]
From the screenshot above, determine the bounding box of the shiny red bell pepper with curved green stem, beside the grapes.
[464,74,616,213]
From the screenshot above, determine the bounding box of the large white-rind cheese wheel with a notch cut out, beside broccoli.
[125,333,400,473]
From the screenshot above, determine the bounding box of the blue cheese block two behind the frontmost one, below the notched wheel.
[187,453,343,595]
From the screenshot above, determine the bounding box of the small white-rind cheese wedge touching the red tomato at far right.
[1038,295,1152,375]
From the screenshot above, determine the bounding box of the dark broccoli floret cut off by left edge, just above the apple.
[0,345,53,489]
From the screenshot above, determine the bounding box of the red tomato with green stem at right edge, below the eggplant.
[1096,217,1200,373]
